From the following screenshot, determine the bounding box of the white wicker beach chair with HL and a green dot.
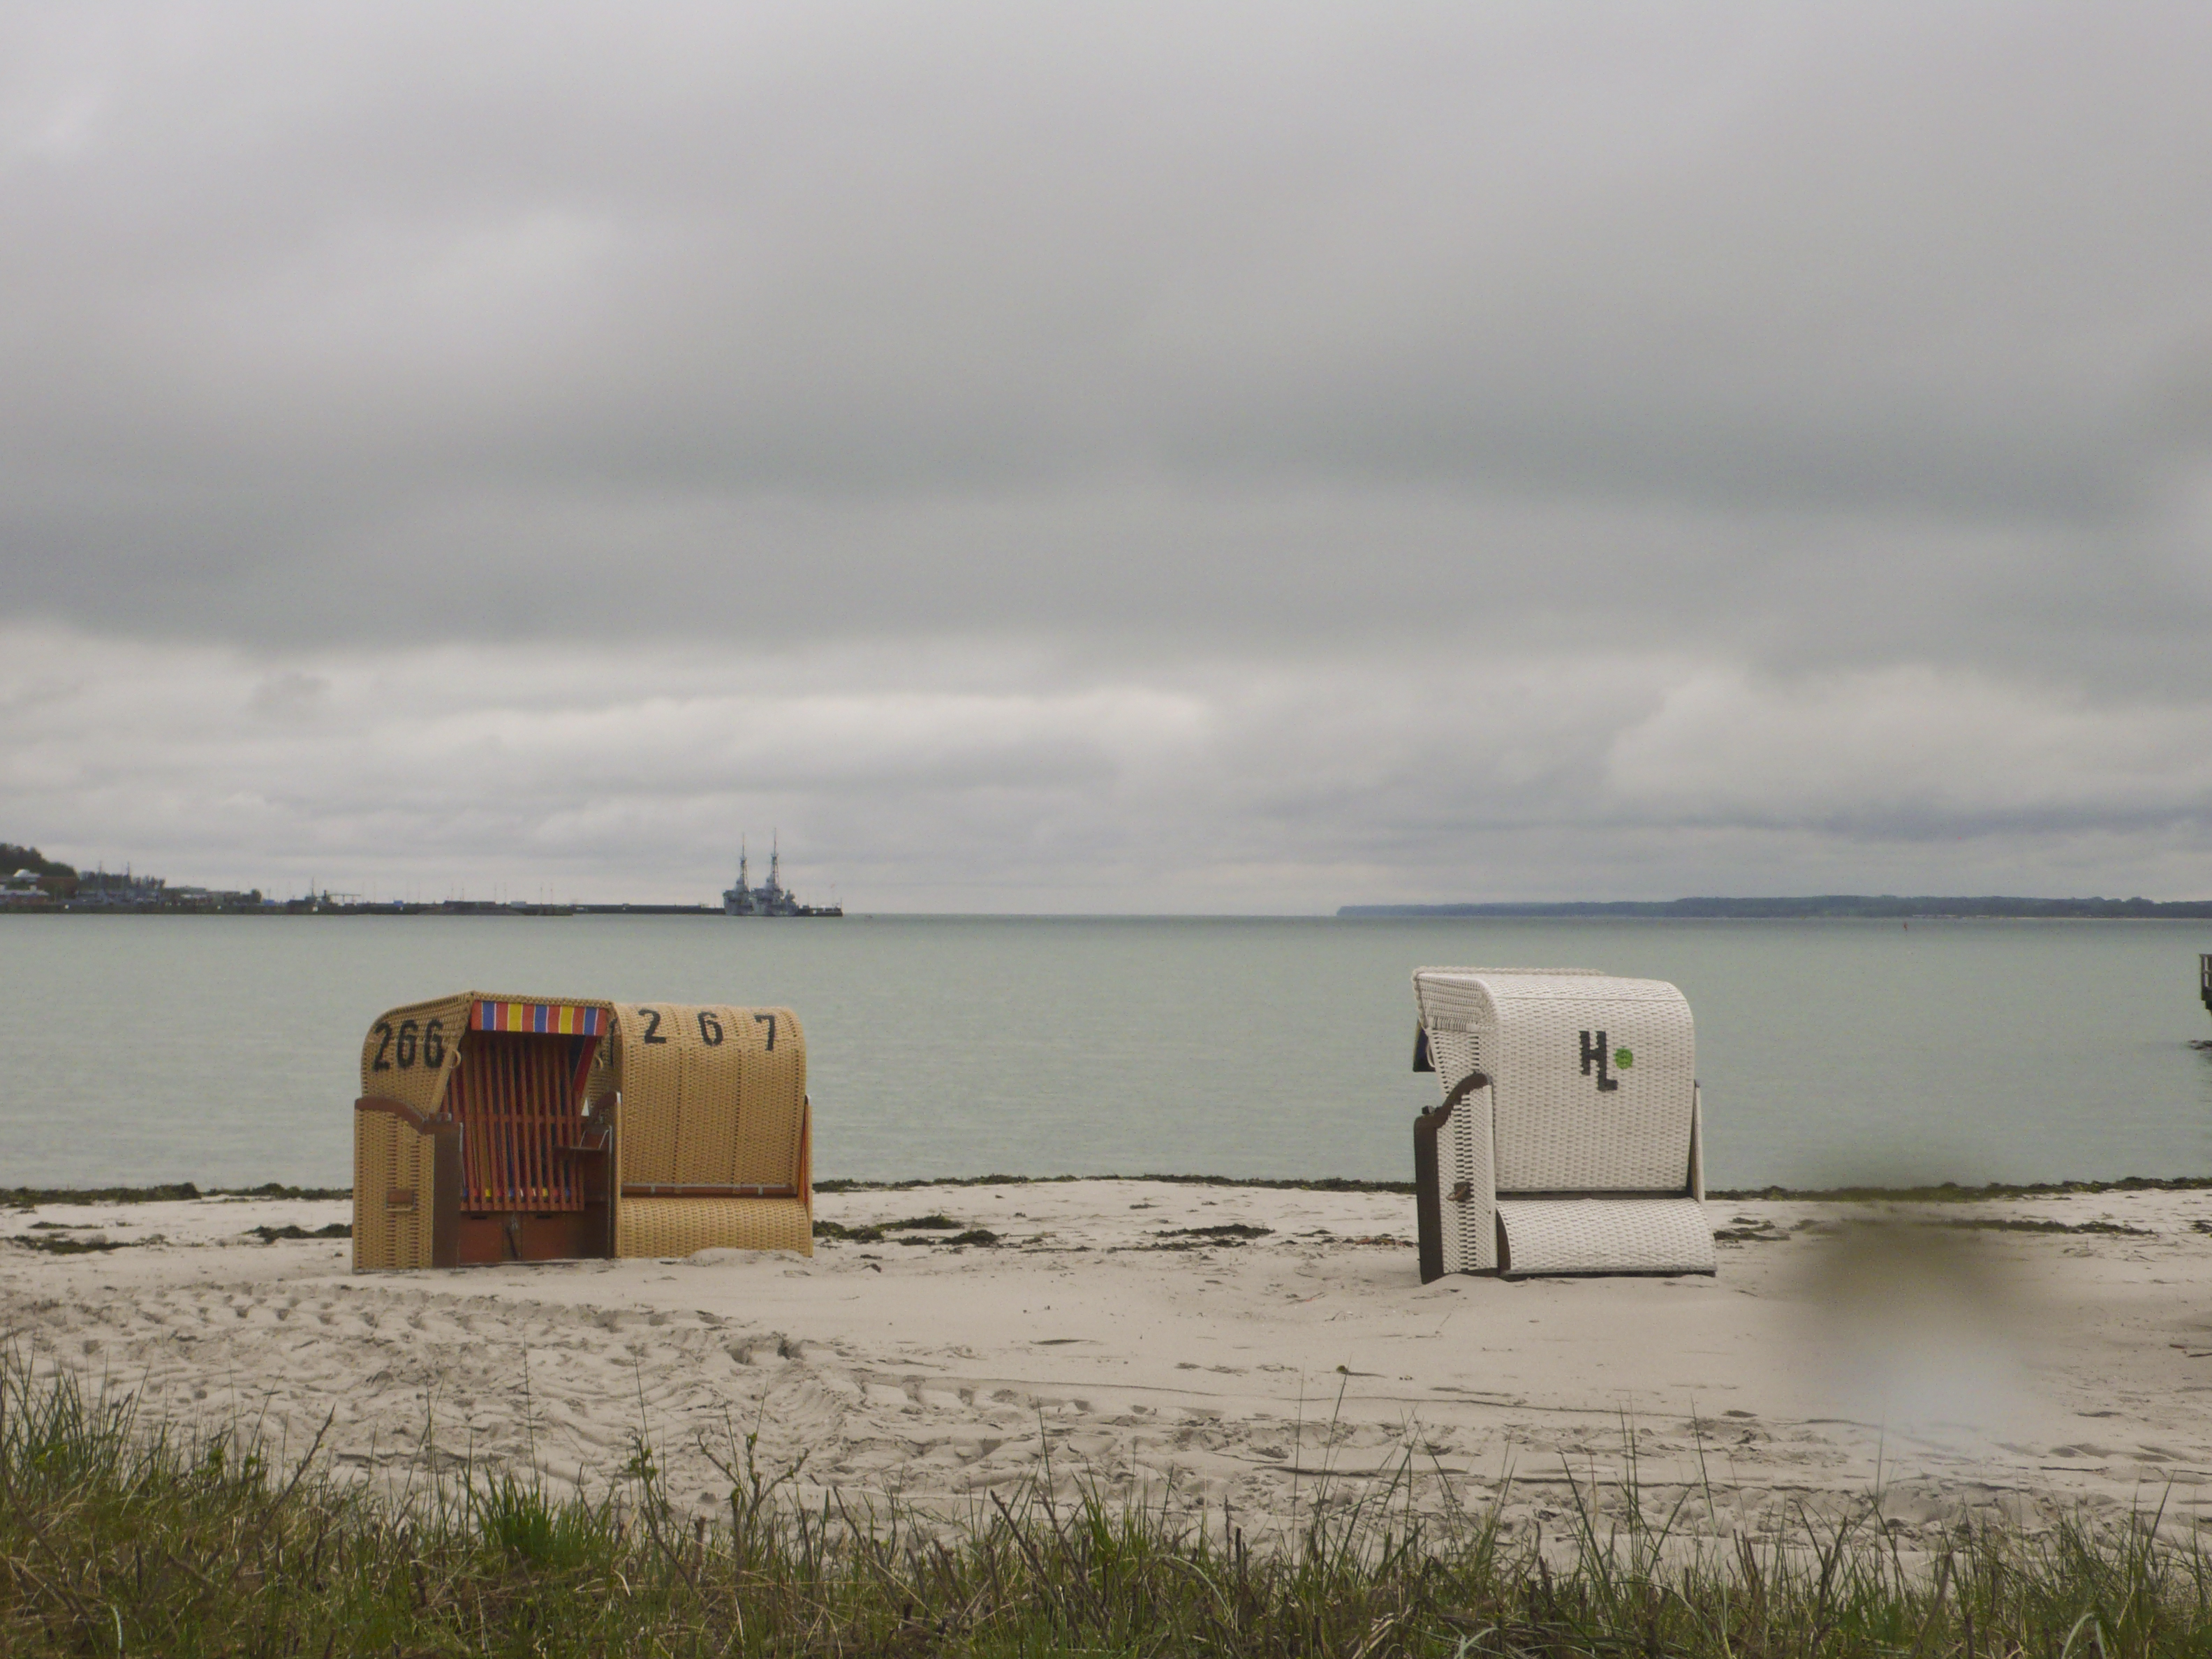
[1413,969,1714,1283]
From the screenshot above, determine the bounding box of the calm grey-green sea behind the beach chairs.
[0,916,2212,1186]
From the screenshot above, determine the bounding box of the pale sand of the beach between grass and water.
[0,1181,2212,1528]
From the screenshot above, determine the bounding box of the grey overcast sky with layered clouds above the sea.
[0,0,2212,911]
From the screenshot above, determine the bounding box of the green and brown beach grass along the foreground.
[0,1358,2212,1659]
